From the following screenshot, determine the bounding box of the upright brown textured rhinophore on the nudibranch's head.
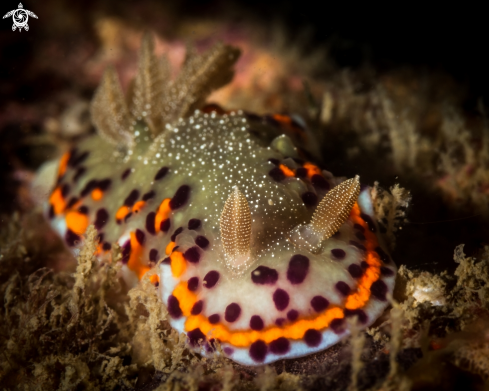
[220,187,251,268]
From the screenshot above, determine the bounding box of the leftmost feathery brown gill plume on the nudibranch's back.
[90,68,133,147]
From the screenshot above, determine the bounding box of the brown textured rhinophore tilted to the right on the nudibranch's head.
[311,175,360,240]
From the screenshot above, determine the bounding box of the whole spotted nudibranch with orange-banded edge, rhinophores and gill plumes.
[46,37,396,365]
